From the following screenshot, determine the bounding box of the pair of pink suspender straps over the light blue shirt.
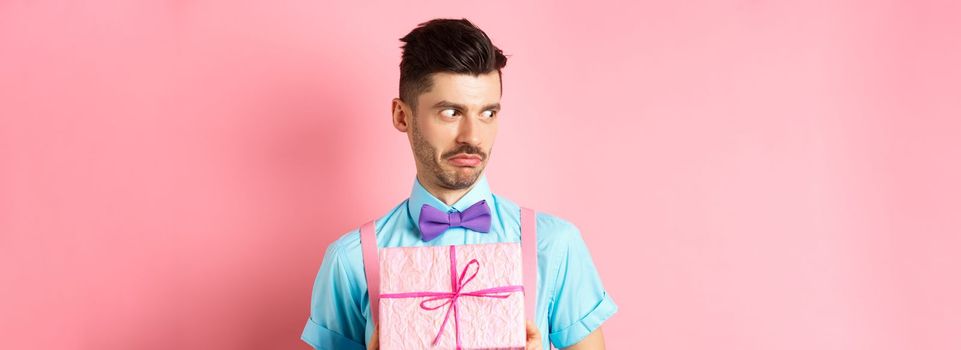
[360,208,537,323]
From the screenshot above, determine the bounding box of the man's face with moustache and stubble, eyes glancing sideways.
[408,71,501,189]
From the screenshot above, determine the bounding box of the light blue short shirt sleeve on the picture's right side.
[549,223,617,348]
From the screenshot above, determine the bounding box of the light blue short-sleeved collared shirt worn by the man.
[301,175,617,350]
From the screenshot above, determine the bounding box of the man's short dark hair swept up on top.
[400,18,507,108]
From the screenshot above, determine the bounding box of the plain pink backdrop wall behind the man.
[0,0,961,349]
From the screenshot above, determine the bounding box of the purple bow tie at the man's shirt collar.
[418,200,491,242]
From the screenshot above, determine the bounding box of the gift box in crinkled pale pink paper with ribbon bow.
[378,243,526,350]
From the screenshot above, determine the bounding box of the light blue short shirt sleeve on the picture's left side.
[300,234,367,350]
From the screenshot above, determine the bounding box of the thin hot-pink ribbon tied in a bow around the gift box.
[380,245,524,350]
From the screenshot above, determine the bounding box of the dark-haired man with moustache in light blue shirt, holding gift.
[301,19,617,350]
